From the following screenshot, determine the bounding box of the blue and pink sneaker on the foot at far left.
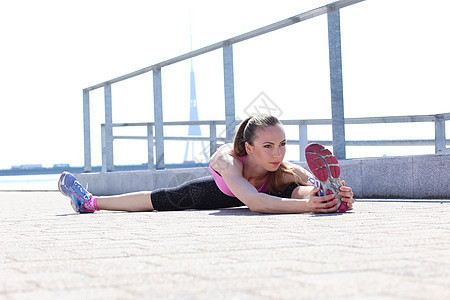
[58,172,98,213]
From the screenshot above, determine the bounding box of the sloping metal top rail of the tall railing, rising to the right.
[84,0,364,92]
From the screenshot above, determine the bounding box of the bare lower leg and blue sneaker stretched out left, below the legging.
[58,172,154,213]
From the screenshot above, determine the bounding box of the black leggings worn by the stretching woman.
[151,176,298,210]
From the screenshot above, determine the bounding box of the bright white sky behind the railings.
[0,0,450,168]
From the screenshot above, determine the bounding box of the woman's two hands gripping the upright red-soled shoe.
[307,181,355,213]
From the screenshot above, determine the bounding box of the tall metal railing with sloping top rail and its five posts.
[83,0,364,172]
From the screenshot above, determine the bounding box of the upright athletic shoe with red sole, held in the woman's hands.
[305,143,348,213]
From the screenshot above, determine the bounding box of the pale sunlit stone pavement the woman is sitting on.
[0,192,450,299]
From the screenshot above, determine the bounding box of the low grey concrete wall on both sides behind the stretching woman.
[77,154,450,199]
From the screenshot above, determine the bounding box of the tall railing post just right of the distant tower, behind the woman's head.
[223,44,236,143]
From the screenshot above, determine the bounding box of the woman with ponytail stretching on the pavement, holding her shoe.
[58,116,354,213]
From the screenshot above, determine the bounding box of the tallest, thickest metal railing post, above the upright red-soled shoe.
[327,5,346,159]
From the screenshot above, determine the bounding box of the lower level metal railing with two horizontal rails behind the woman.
[101,113,450,172]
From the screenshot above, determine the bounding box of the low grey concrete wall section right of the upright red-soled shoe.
[340,154,450,199]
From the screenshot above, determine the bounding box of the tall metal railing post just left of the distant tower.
[153,68,165,170]
